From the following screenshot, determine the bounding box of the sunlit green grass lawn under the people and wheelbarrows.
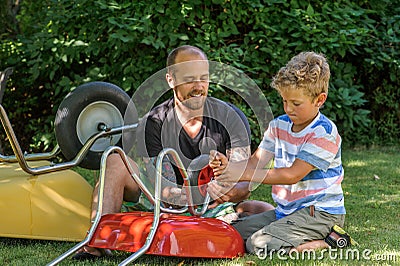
[0,147,400,266]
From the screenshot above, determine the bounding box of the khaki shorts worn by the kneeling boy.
[232,207,345,254]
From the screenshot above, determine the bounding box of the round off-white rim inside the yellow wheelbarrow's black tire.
[76,101,124,152]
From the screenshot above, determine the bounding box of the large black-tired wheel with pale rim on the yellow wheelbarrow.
[55,81,134,169]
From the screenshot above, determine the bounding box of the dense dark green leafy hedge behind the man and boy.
[0,0,400,150]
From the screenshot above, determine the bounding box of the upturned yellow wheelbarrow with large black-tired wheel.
[0,72,136,241]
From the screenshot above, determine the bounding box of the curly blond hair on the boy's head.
[271,52,331,98]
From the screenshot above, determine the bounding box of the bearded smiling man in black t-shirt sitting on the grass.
[74,45,273,259]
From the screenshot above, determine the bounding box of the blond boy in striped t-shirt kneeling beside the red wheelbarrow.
[210,52,346,254]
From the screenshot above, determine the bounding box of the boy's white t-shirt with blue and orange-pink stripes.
[259,113,346,218]
